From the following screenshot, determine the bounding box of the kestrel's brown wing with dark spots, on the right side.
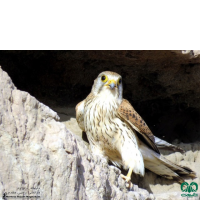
[118,99,160,153]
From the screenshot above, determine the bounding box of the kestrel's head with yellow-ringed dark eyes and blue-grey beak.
[92,71,123,100]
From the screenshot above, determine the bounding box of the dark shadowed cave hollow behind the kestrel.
[0,50,200,143]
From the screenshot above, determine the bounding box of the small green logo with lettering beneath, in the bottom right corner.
[181,182,198,197]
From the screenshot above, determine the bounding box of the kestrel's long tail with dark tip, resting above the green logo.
[140,145,196,183]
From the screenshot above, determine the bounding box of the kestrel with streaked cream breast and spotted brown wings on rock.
[76,71,195,186]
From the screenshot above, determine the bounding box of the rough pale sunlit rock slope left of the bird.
[0,68,154,200]
